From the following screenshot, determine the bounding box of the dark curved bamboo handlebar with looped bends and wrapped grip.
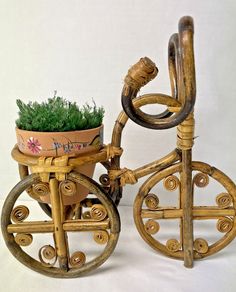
[122,16,196,130]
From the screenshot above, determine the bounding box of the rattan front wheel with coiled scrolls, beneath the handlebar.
[134,162,236,259]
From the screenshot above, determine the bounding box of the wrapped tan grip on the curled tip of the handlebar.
[124,57,158,90]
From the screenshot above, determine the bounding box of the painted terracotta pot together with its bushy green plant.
[16,96,104,204]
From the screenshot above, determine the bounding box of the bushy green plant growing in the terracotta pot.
[16,96,104,132]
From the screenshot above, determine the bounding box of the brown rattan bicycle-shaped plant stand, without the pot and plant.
[1,16,236,278]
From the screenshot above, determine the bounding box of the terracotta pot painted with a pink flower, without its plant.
[16,125,103,205]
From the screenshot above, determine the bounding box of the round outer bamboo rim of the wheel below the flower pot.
[1,173,120,278]
